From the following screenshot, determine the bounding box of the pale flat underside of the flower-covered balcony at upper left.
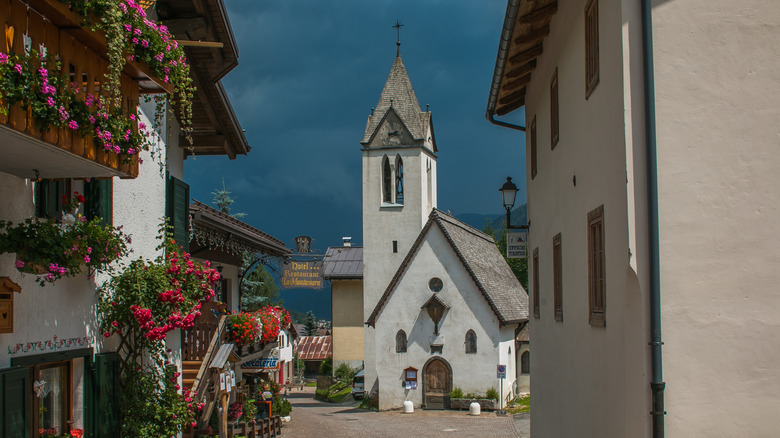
[0,125,132,179]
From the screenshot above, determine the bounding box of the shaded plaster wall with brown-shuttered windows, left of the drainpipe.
[526,0,649,437]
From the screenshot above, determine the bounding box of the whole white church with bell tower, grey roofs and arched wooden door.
[325,38,528,410]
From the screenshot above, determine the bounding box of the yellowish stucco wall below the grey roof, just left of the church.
[331,280,365,368]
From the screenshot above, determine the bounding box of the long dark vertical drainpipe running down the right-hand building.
[642,0,666,438]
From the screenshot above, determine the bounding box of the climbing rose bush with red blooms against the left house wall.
[98,231,220,438]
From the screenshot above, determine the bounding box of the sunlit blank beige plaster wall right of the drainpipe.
[653,0,780,437]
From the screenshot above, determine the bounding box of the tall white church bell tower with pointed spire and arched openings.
[360,36,438,394]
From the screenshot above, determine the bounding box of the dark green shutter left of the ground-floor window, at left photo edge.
[0,367,32,438]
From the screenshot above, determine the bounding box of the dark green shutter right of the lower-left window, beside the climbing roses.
[92,353,119,438]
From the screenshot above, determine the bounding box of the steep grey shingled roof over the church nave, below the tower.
[366,209,528,326]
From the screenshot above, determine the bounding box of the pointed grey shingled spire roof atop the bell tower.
[361,55,436,152]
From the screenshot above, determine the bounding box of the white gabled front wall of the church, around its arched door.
[376,226,515,410]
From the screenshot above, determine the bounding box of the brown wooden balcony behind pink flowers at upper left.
[0,0,172,178]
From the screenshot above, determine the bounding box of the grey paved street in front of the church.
[282,388,524,438]
